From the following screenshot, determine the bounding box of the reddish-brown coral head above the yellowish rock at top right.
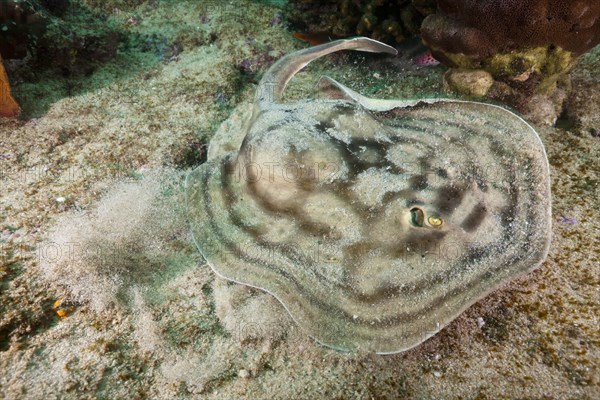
[421,0,600,61]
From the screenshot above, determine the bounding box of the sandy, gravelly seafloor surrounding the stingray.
[0,1,600,399]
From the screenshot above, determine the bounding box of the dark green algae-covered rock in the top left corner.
[0,0,123,80]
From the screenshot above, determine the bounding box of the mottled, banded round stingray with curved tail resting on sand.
[186,38,551,354]
